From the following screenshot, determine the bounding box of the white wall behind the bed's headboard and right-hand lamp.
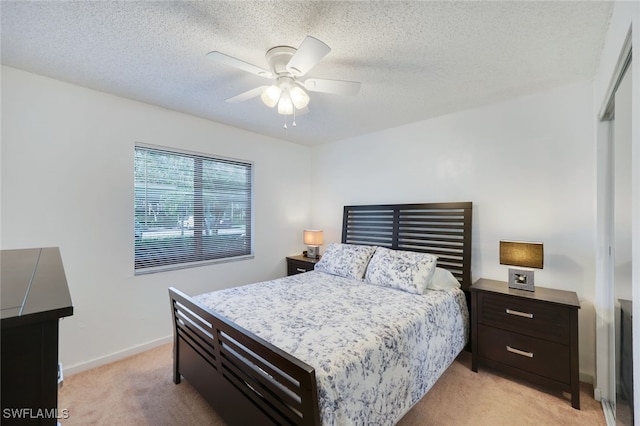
[312,82,595,380]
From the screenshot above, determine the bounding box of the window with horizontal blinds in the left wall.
[134,145,253,273]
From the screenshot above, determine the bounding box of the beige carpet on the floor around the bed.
[59,345,605,426]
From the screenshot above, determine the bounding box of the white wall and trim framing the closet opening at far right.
[593,1,640,424]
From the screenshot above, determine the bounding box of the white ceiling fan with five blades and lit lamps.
[207,36,360,120]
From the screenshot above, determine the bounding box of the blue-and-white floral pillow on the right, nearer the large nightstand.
[365,247,438,294]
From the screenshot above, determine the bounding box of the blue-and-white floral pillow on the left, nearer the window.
[315,243,376,281]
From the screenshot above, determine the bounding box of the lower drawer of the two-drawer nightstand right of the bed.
[478,325,571,384]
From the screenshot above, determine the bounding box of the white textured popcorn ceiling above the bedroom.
[0,0,612,145]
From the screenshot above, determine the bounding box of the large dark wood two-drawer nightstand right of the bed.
[471,279,580,409]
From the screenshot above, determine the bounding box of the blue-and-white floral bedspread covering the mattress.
[195,271,469,425]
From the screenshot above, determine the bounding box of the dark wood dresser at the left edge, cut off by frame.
[0,247,73,425]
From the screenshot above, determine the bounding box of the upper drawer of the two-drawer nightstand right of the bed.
[478,293,571,344]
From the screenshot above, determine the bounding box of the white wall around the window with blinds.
[0,67,311,372]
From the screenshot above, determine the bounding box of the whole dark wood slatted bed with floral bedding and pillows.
[169,202,472,425]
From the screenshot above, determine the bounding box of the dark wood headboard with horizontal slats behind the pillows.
[342,202,473,291]
